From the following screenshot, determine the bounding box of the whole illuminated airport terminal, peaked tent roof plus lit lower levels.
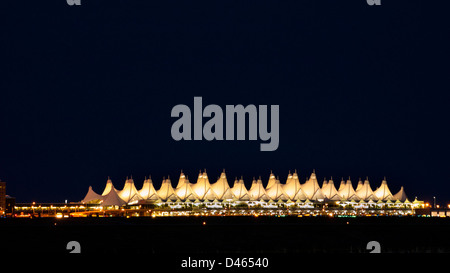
[74,171,424,216]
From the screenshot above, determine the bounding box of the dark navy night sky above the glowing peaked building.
[0,0,450,205]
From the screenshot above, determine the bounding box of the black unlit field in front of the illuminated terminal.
[0,217,450,255]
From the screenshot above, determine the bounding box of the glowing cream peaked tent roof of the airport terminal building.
[81,170,421,209]
